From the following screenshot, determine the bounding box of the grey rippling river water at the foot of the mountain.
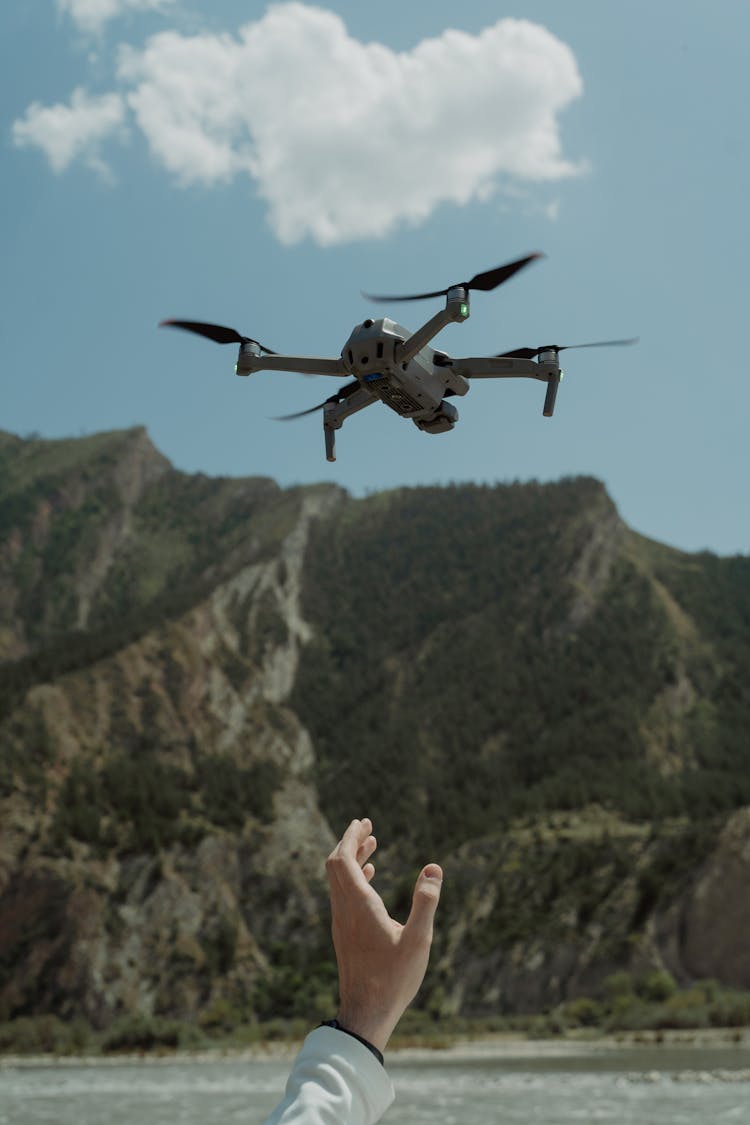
[0,1044,750,1125]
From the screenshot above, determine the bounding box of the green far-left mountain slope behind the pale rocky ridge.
[0,430,319,714]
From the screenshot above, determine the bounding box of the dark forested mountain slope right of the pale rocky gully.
[292,479,750,846]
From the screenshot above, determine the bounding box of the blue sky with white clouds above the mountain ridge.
[0,0,750,555]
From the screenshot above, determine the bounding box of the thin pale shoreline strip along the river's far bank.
[0,1027,750,1071]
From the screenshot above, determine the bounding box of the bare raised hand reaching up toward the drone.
[326,818,443,1051]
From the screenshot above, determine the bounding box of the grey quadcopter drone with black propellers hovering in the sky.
[161,254,638,461]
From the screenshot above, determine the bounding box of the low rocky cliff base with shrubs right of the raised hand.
[425,808,750,1015]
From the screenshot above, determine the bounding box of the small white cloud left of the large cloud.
[13,89,125,174]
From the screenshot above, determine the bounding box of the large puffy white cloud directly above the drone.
[13,0,582,244]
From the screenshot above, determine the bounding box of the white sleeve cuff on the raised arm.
[263,1027,394,1125]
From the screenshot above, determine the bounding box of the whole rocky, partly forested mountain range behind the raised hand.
[0,429,750,1027]
